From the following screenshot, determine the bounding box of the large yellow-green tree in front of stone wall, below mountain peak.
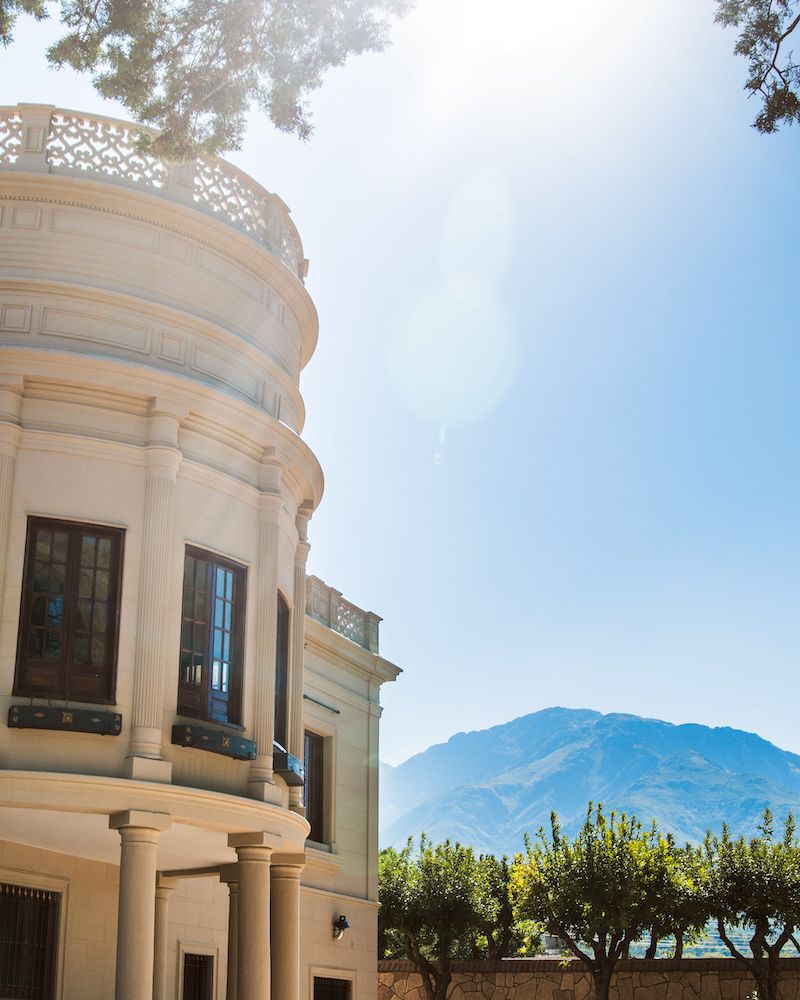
[511,803,671,1000]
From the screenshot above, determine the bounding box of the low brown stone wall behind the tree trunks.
[378,958,800,1000]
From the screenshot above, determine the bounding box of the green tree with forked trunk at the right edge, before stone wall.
[705,809,800,1000]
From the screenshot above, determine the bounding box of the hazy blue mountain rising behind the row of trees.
[381,708,800,854]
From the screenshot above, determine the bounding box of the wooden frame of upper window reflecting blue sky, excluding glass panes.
[177,545,247,729]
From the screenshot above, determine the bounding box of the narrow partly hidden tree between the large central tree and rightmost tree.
[645,835,711,958]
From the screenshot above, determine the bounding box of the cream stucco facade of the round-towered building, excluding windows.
[0,106,398,1000]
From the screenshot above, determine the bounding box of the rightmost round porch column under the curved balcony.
[270,854,305,1000]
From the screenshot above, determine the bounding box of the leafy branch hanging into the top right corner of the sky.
[715,0,800,132]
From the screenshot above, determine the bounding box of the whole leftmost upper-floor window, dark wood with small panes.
[14,517,124,704]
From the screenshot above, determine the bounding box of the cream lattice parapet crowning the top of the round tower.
[0,104,308,281]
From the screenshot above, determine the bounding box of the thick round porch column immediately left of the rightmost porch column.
[228,833,282,1000]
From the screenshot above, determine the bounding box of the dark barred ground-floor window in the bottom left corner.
[0,882,61,1000]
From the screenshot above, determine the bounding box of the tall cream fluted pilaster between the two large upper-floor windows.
[128,399,185,781]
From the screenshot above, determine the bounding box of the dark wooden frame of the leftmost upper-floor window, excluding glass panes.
[12,515,125,705]
